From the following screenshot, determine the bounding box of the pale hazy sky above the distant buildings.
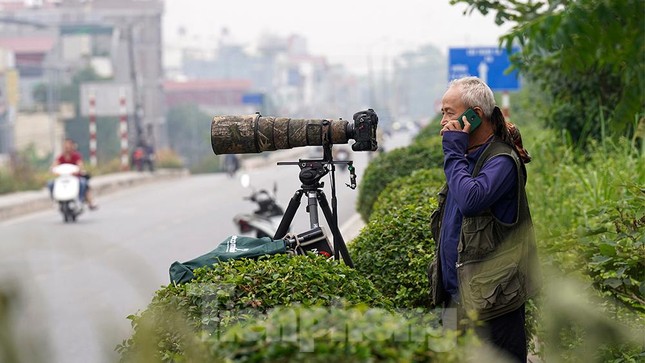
[164,0,509,73]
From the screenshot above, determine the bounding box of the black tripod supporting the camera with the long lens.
[273,145,356,268]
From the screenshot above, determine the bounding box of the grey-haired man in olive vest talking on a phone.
[430,77,538,363]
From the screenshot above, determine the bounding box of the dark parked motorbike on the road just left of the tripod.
[233,174,284,238]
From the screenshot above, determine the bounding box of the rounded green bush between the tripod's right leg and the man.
[349,169,443,308]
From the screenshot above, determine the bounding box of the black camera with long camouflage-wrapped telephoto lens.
[211,109,378,155]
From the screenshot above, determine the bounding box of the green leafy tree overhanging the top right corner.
[451,0,645,146]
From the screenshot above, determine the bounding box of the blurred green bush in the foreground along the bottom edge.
[193,306,481,363]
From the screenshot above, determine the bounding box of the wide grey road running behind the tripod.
[0,131,408,363]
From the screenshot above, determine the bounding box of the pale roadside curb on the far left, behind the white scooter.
[0,169,189,221]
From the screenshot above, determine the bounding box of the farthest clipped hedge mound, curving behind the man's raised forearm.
[356,141,443,221]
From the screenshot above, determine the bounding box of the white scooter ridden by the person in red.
[52,164,84,223]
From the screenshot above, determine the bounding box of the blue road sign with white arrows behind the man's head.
[448,47,520,91]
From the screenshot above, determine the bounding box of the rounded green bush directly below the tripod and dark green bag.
[117,255,391,361]
